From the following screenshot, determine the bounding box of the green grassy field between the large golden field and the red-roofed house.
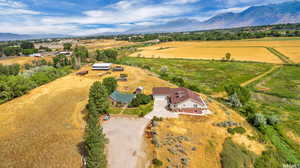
[120,57,273,94]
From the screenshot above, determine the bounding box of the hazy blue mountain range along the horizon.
[0,1,300,41]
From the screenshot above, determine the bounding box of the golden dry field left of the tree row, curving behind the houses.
[0,64,172,168]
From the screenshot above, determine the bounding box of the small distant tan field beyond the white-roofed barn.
[79,39,134,51]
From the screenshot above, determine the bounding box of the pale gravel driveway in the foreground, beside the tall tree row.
[103,118,149,168]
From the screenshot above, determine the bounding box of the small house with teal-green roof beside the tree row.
[109,90,135,107]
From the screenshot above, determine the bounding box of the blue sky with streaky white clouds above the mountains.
[0,0,296,36]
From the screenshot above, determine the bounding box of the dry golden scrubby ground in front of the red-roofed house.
[148,95,265,168]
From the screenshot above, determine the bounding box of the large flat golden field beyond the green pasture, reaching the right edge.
[131,40,300,64]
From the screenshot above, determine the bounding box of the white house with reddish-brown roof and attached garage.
[153,87,211,115]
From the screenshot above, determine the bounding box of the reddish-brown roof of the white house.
[153,87,205,105]
